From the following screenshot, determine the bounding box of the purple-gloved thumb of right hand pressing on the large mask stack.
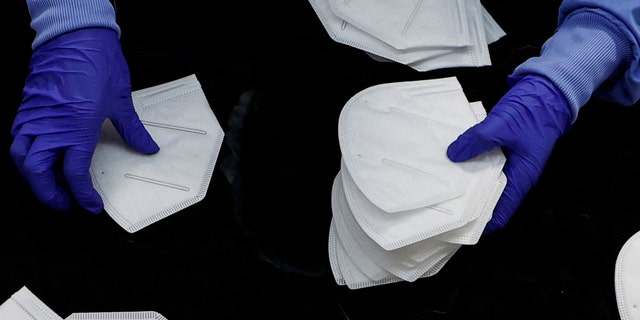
[447,114,504,162]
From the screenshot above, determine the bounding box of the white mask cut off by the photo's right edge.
[614,232,640,320]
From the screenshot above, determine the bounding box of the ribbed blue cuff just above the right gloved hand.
[513,10,633,121]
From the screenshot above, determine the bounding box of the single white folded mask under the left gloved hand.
[91,75,224,232]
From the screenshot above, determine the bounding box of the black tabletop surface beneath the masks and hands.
[0,0,640,320]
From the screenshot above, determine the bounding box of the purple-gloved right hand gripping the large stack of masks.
[447,75,572,234]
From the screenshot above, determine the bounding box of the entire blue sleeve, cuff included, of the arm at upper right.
[511,0,640,121]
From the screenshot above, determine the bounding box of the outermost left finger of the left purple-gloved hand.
[22,139,73,210]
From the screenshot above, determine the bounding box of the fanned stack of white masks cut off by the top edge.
[309,0,505,71]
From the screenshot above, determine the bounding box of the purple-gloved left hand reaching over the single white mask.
[11,28,159,213]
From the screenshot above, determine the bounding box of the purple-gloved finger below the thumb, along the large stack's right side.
[484,153,537,234]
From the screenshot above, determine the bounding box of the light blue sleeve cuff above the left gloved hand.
[27,0,120,50]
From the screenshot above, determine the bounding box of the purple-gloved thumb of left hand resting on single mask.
[111,102,160,154]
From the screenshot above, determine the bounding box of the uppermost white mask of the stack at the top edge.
[328,0,470,50]
